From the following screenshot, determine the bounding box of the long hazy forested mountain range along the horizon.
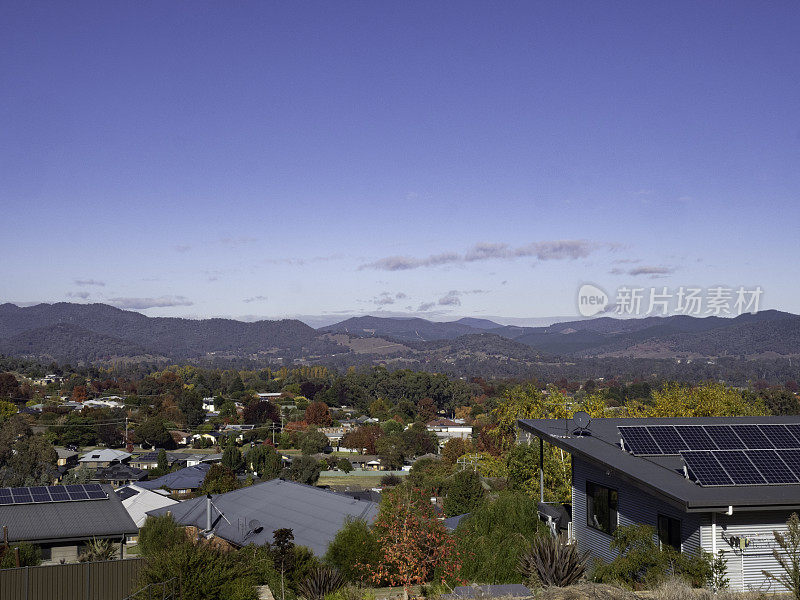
[0,303,800,366]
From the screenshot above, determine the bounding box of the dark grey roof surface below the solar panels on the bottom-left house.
[0,485,138,542]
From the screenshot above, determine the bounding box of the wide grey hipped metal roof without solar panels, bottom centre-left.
[148,479,378,556]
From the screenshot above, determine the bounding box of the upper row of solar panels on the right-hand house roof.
[619,423,800,456]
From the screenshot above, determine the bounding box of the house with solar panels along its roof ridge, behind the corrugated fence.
[0,484,138,564]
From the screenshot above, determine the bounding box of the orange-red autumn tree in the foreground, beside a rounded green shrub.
[367,486,461,597]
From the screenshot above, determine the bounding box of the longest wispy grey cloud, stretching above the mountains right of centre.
[359,240,607,271]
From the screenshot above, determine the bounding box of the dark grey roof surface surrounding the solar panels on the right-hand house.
[519,416,800,510]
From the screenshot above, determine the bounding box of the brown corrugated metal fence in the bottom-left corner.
[0,558,144,600]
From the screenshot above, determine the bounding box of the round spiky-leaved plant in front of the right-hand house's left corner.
[519,535,588,587]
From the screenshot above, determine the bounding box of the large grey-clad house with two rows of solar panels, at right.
[518,416,800,592]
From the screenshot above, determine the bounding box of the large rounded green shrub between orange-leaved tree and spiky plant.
[455,492,547,583]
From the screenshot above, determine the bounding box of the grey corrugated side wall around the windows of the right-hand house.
[572,456,701,562]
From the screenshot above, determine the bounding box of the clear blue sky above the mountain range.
[0,1,800,320]
